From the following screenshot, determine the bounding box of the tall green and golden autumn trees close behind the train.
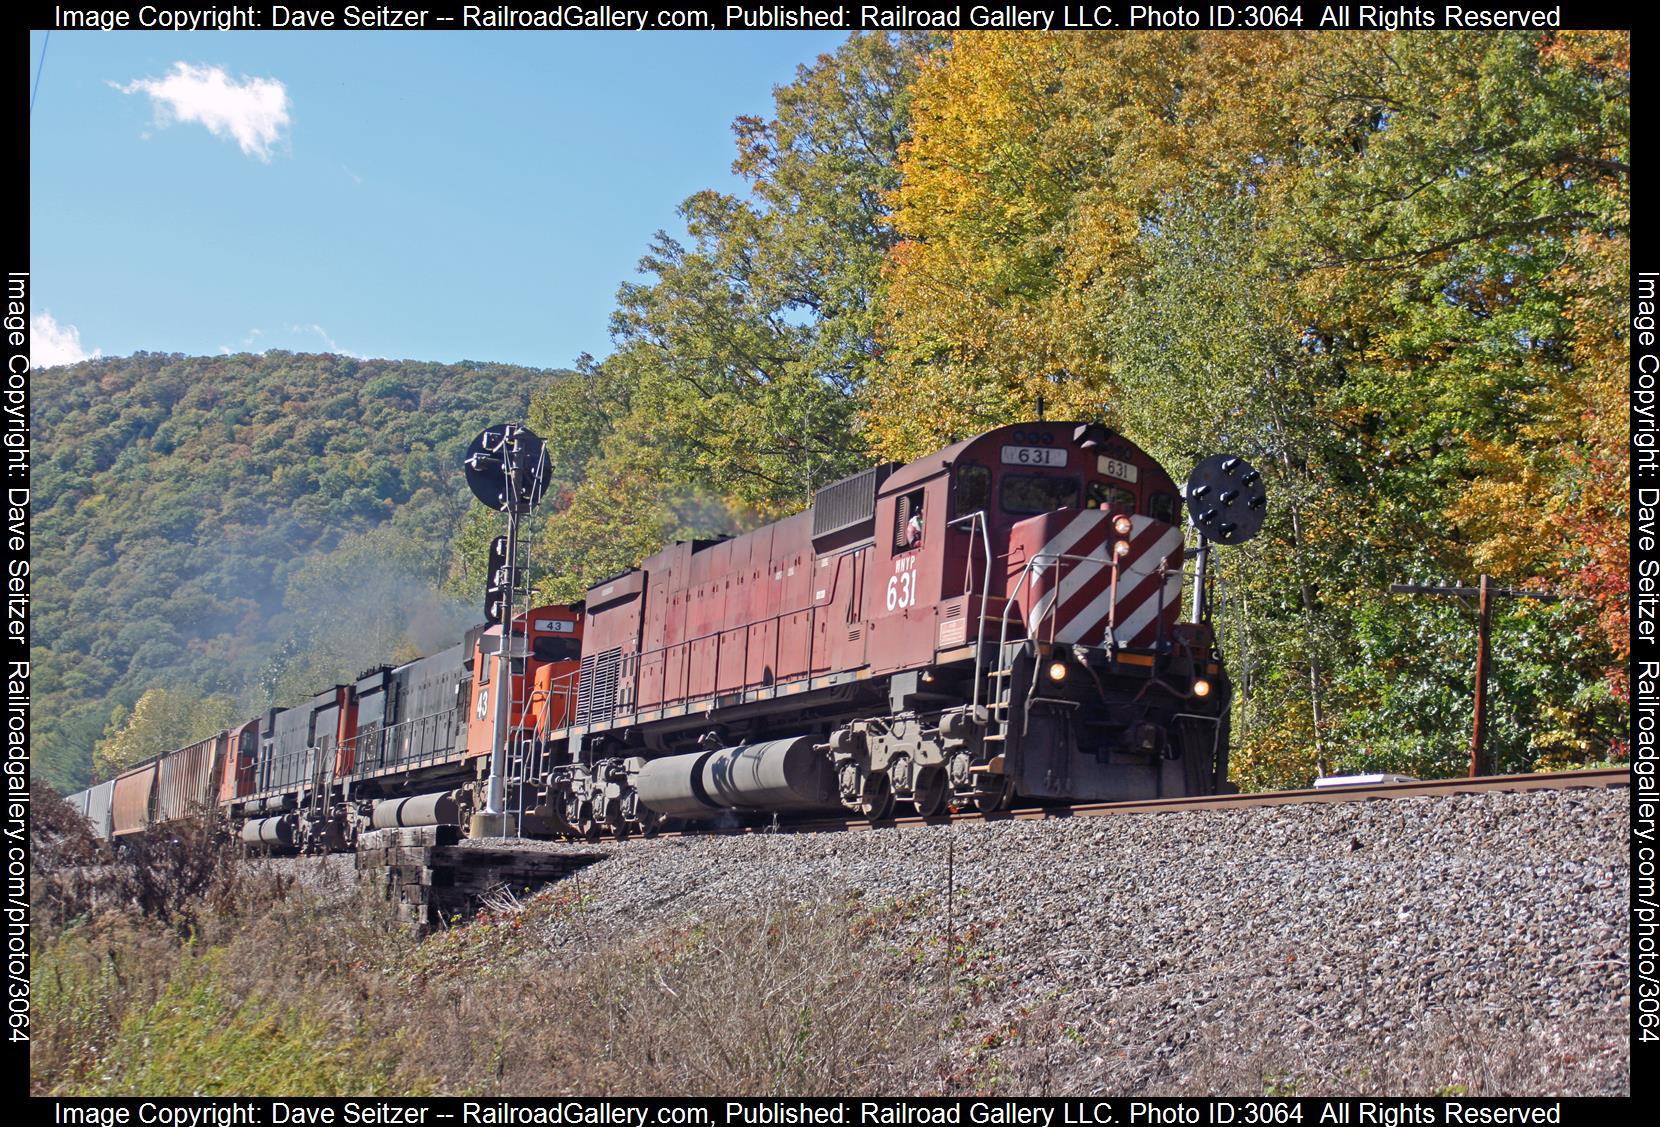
[514,32,1630,787]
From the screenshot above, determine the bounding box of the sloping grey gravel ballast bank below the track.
[494,790,1630,1095]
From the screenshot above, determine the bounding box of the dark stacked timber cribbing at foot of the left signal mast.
[357,825,606,929]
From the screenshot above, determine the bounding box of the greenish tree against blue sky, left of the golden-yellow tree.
[531,35,931,598]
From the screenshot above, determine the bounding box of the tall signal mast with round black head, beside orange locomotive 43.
[461,423,551,837]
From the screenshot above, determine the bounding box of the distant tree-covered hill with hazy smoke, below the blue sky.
[30,352,559,788]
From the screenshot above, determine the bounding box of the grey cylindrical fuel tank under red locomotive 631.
[636,735,842,818]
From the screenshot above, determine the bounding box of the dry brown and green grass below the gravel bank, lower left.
[30,848,945,1094]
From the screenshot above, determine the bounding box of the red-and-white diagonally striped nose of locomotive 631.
[1026,510,1182,647]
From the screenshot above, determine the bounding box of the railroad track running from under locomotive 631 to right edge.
[680,767,1632,837]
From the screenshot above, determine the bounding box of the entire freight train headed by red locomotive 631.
[71,422,1262,851]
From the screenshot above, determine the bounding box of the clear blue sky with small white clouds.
[30,32,843,367]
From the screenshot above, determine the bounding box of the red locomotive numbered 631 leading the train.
[530,416,1228,833]
